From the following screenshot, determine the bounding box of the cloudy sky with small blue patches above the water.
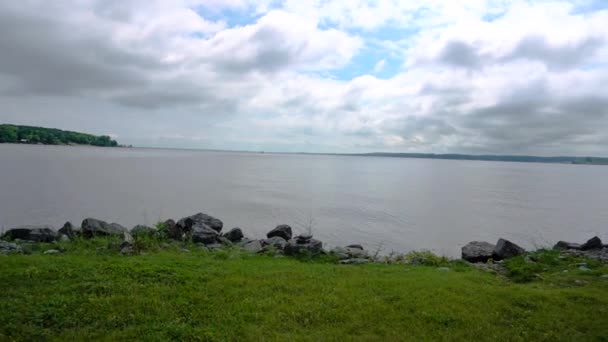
[0,0,608,156]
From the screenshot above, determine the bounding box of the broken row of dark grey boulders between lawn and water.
[0,213,608,271]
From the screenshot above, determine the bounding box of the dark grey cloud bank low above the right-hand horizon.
[455,81,608,154]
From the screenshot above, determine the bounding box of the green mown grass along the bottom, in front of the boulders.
[0,239,608,341]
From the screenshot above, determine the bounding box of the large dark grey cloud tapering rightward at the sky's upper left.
[0,9,159,95]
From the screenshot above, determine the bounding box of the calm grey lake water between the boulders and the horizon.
[0,144,608,256]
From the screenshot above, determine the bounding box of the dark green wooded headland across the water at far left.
[0,125,118,147]
